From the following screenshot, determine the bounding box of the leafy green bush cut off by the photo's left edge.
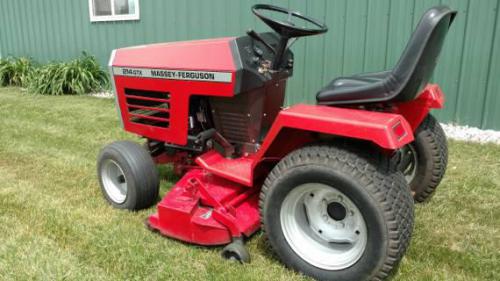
[0,58,36,88]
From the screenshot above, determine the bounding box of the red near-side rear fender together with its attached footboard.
[196,104,413,187]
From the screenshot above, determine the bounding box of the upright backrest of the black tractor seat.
[392,6,457,101]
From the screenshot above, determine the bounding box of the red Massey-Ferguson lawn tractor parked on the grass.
[97,5,456,280]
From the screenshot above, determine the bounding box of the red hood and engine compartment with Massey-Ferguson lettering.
[109,33,293,156]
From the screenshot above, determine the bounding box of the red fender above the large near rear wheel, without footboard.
[254,104,413,165]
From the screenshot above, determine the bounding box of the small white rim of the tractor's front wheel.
[101,159,128,204]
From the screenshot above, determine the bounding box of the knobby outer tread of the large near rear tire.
[259,144,414,280]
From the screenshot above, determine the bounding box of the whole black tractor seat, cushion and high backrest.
[316,6,456,105]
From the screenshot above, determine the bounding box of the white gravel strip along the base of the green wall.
[90,92,500,144]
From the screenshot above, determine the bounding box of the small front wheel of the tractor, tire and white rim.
[97,141,160,211]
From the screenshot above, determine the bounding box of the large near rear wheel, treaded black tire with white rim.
[259,145,414,280]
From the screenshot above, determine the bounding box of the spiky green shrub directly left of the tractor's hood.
[29,53,109,95]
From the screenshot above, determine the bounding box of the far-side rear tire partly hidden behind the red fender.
[401,114,448,203]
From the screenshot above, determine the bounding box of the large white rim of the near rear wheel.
[280,183,368,270]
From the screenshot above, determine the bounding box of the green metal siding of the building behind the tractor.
[0,0,500,129]
